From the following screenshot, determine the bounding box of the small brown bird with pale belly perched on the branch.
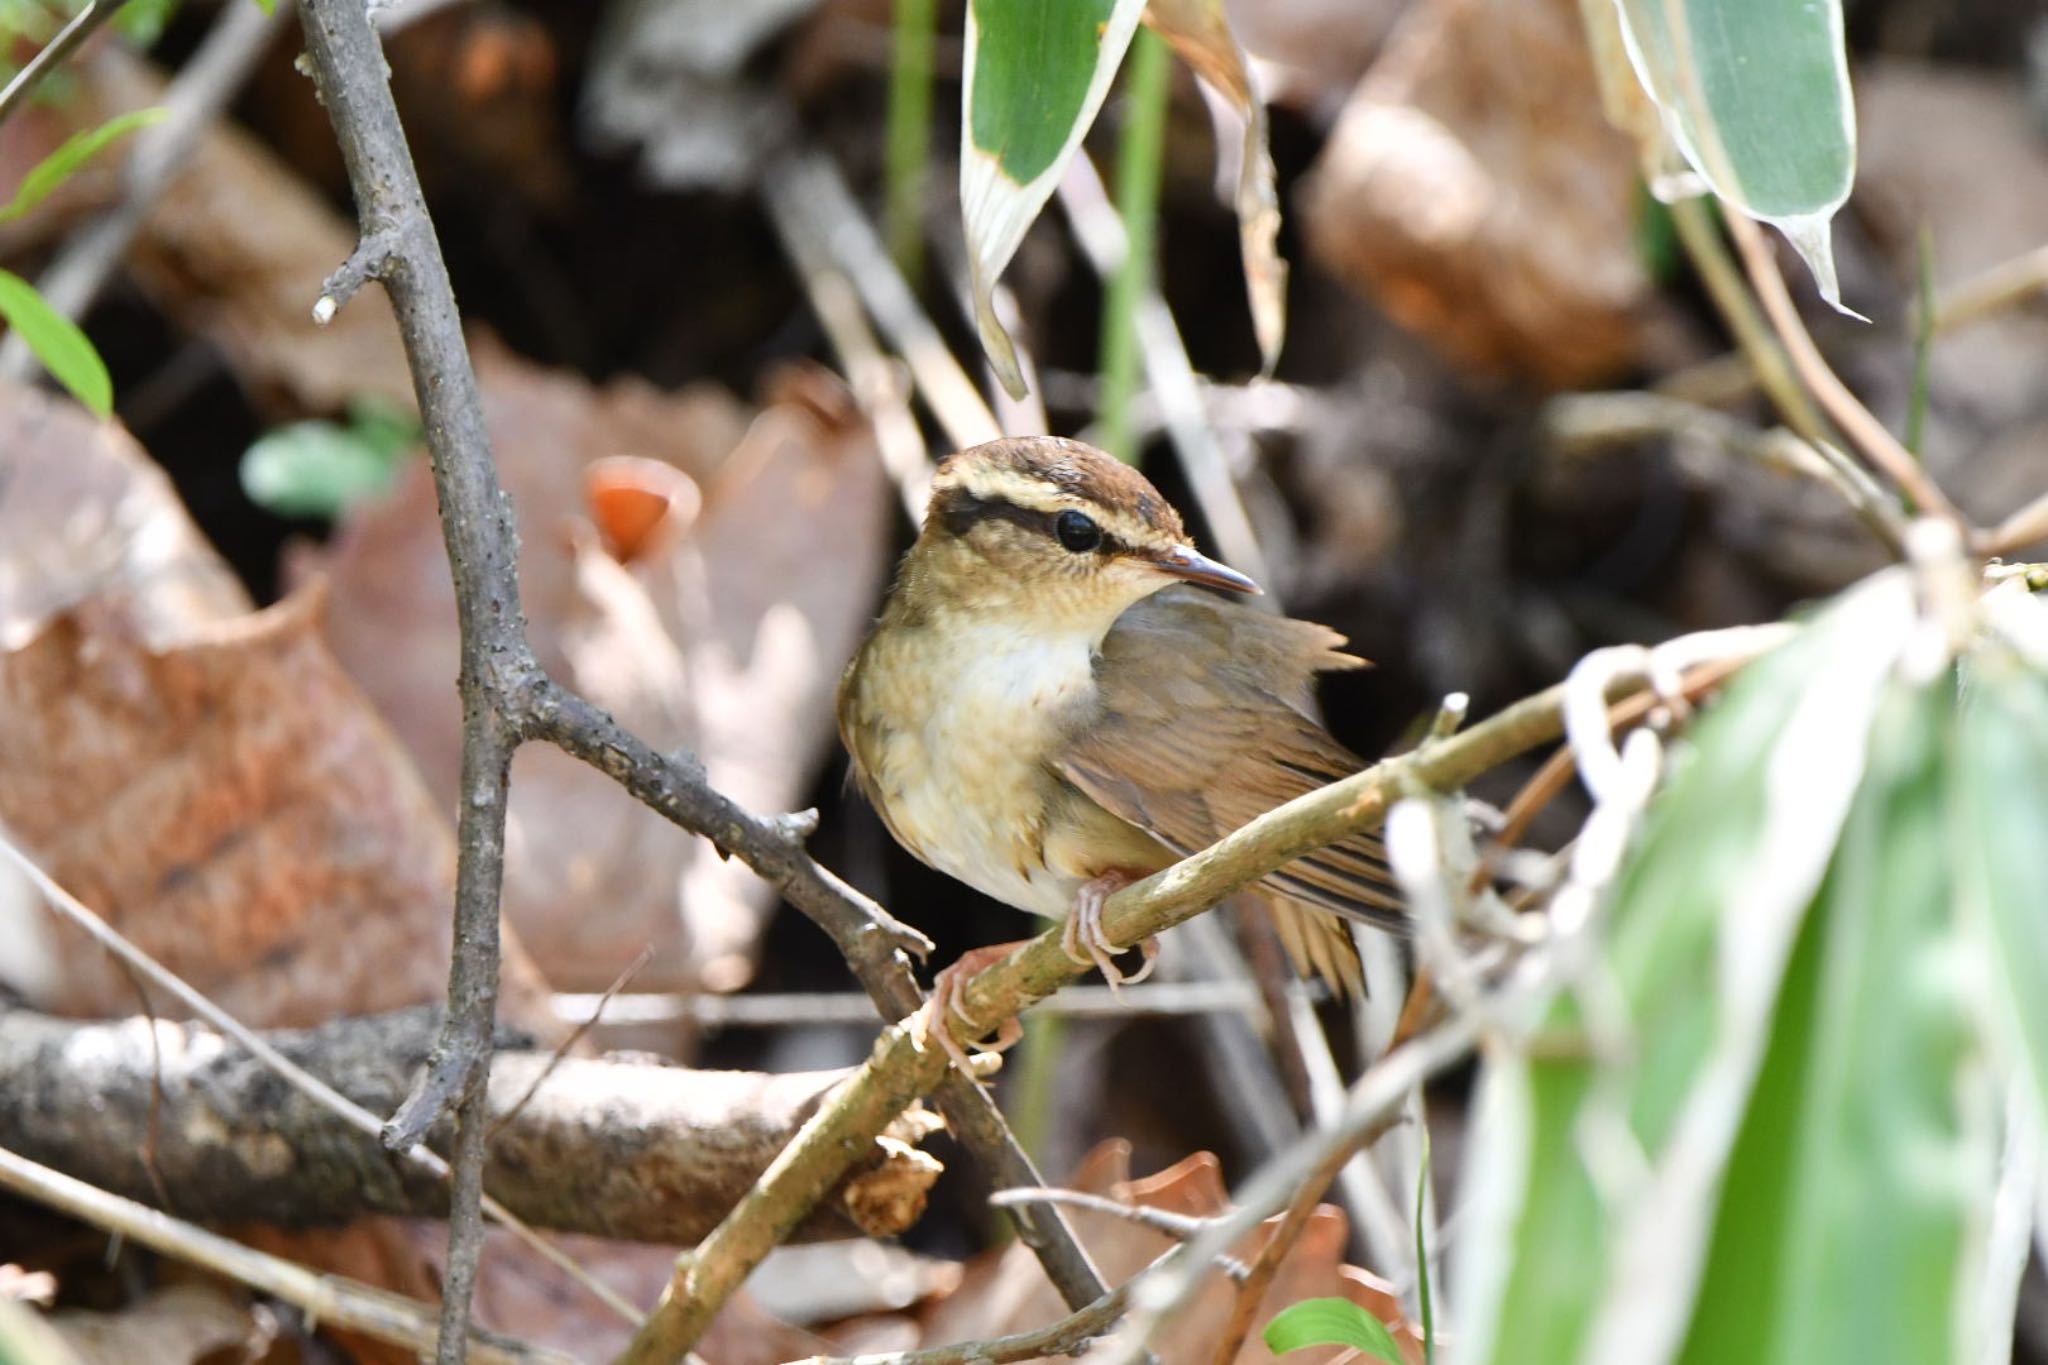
[840,436,1401,1060]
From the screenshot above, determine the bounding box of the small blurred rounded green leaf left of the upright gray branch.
[242,403,420,520]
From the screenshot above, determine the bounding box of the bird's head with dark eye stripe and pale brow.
[913,436,1260,630]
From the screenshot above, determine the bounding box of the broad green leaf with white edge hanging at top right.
[1618,0,1855,311]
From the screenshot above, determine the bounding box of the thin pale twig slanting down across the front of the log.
[0,837,641,1322]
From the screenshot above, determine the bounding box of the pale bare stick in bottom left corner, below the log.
[0,1148,575,1365]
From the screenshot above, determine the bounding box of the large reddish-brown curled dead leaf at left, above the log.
[0,593,466,1027]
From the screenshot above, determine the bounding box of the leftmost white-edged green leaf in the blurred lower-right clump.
[1460,571,1915,1365]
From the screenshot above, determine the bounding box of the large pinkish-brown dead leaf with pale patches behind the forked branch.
[297,344,889,990]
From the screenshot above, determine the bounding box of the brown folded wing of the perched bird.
[1053,587,1403,958]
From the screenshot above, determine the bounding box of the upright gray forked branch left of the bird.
[288,0,1104,1363]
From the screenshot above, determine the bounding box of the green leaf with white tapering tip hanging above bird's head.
[961,0,1145,397]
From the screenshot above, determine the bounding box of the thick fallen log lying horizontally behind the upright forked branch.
[0,1009,938,1246]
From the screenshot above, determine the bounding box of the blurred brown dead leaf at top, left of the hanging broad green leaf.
[1303,0,1659,387]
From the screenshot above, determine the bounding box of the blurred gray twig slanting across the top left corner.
[0,0,291,377]
